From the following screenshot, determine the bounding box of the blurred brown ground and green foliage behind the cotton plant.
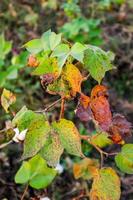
[0,0,133,200]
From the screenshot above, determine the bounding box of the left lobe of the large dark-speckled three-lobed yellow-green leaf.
[22,114,50,159]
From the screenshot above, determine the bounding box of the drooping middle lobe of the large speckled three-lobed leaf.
[40,130,64,167]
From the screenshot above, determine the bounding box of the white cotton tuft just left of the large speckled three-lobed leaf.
[12,128,28,143]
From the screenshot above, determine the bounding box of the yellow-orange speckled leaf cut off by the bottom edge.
[90,168,120,200]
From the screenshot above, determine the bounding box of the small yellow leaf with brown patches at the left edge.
[1,88,16,113]
